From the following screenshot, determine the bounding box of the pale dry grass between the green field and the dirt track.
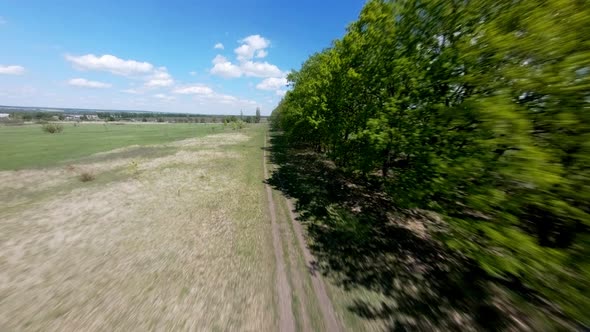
[0,126,277,331]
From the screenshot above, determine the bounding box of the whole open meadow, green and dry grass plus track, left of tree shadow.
[0,124,345,331]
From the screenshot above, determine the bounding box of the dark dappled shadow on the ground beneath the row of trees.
[267,134,508,331]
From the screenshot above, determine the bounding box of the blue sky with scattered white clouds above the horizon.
[0,0,364,115]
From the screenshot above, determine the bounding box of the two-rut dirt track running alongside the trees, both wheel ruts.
[264,137,342,331]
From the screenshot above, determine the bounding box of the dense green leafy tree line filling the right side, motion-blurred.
[271,0,590,324]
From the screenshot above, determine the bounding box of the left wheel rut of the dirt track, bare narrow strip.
[262,136,295,332]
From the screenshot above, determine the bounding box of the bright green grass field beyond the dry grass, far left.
[0,123,223,170]
